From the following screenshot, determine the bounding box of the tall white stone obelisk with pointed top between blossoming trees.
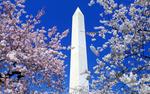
[69,8,89,94]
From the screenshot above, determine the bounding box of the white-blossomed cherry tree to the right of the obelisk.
[88,0,150,94]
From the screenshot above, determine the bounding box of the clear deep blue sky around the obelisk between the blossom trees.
[25,0,101,90]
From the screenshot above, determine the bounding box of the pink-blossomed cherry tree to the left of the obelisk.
[0,0,68,94]
